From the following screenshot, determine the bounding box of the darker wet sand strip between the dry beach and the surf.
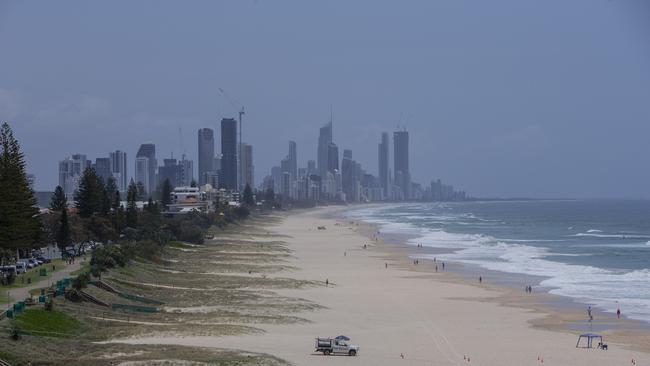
[334,204,650,352]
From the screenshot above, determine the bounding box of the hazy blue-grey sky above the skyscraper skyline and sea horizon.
[0,0,650,198]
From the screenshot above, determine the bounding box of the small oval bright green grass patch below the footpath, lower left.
[13,305,82,338]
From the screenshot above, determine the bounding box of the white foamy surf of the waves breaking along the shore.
[356,206,650,322]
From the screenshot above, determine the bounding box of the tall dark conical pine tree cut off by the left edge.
[0,122,42,258]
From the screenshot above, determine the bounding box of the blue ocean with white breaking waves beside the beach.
[347,200,650,322]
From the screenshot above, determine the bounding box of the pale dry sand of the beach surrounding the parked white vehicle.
[111,208,650,366]
